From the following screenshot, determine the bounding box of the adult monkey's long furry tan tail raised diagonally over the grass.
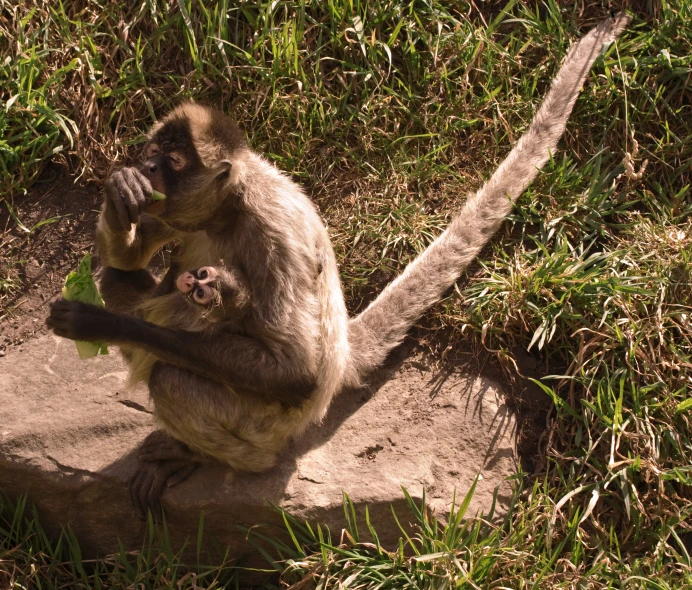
[349,13,629,384]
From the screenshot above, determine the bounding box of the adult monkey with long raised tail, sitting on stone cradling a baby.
[47,14,629,515]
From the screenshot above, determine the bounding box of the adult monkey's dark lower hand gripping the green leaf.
[46,299,120,341]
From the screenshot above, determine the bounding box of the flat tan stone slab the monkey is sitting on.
[0,335,515,556]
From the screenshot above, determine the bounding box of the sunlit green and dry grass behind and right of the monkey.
[0,0,692,588]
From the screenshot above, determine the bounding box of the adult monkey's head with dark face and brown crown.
[140,103,247,230]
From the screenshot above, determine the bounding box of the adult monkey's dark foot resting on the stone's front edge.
[130,430,200,522]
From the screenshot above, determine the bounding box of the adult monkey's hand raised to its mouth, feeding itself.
[105,168,153,231]
